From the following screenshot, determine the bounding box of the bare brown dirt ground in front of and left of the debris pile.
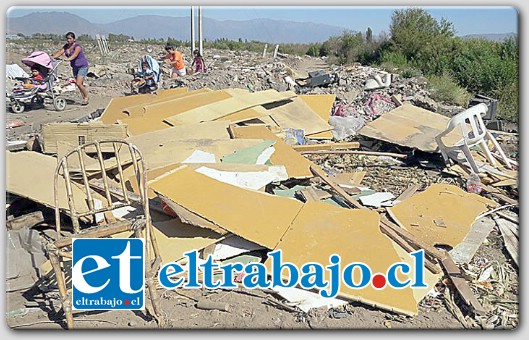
[6,41,518,330]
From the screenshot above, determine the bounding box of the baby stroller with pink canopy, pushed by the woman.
[8,51,72,113]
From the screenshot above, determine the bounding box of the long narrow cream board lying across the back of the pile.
[165,89,296,125]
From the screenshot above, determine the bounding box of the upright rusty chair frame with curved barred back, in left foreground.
[47,140,164,329]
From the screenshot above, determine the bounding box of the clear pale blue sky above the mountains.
[7,6,519,35]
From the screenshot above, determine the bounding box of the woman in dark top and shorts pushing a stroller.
[53,32,88,105]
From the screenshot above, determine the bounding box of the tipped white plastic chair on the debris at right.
[435,103,512,173]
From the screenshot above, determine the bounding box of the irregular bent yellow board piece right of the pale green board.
[232,125,314,178]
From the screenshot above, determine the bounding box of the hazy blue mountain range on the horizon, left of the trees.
[6,12,346,43]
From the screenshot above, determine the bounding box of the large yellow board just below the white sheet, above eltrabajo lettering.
[150,167,302,249]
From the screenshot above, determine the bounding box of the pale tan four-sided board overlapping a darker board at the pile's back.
[269,98,333,135]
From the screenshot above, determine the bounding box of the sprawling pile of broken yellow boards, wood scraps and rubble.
[6,81,518,328]
